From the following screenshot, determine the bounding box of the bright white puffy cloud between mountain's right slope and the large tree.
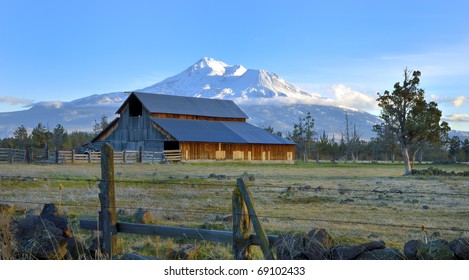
[331,84,378,110]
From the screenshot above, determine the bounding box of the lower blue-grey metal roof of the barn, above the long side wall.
[152,118,295,145]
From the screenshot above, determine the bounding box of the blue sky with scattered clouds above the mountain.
[0,0,469,131]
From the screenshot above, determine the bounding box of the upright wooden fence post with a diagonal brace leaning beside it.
[232,188,252,260]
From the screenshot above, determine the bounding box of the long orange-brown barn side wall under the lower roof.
[181,142,295,160]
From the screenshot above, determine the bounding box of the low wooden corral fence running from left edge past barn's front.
[0,148,165,164]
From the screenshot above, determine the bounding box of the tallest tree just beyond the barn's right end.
[287,112,316,162]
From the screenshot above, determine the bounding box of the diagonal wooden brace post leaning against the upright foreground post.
[233,178,274,260]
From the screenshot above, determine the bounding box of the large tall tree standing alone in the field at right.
[377,69,450,174]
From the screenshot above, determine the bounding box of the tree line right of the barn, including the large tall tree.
[267,69,469,174]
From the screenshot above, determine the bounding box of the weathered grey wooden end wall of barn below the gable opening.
[97,104,168,151]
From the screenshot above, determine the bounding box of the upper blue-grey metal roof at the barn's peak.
[118,92,248,119]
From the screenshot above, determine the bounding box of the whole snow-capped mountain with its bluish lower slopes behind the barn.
[0,57,462,139]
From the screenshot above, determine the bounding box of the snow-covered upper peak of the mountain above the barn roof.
[139,57,321,102]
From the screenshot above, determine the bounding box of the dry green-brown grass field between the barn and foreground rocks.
[0,163,469,259]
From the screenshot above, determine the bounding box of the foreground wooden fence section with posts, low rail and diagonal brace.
[80,144,278,260]
